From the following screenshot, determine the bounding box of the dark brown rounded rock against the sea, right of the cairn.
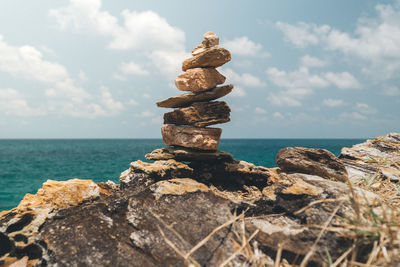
[275,147,348,182]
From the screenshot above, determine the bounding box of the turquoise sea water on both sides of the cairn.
[0,139,364,211]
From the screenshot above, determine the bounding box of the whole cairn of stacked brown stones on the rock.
[146,32,233,162]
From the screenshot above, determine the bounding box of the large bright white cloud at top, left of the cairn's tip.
[49,0,189,78]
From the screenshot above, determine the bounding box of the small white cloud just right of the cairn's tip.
[223,36,269,57]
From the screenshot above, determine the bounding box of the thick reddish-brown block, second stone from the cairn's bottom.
[161,124,222,150]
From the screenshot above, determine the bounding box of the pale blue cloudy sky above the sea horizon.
[0,0,400,138]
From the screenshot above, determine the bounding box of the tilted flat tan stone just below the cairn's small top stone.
[182,47,231,71]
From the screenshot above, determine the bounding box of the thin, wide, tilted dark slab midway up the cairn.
[157,84,233,108]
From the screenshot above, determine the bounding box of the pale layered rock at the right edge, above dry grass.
[339,133,400,181]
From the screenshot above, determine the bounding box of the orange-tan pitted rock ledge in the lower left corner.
[0,179,116,266]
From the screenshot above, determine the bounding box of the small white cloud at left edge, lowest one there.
[0,88,45,117]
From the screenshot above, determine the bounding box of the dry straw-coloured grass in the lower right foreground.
[154,166,400,267]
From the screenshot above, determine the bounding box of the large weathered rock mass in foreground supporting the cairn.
[0,135,399,267]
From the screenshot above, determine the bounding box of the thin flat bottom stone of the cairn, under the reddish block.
[146,147,233,162]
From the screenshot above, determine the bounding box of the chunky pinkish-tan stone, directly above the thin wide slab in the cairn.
[175,68,226,92]
